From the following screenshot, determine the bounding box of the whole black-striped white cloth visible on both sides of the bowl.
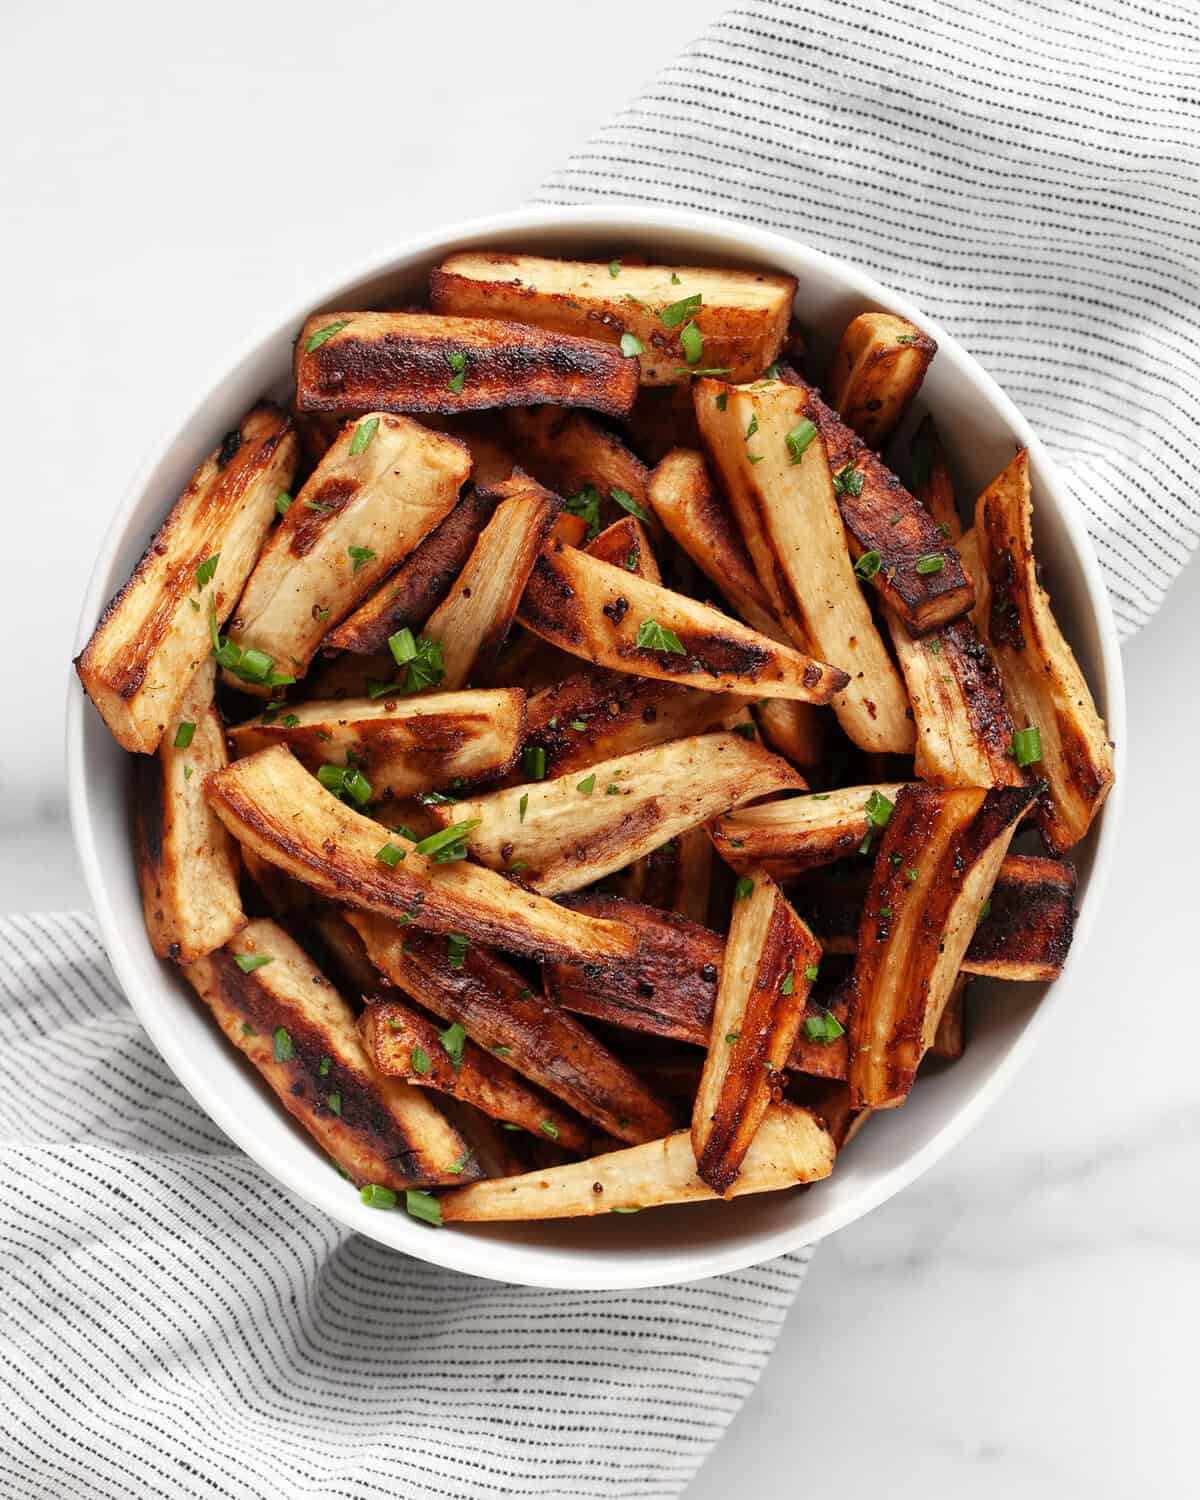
[0,0,1200,1500]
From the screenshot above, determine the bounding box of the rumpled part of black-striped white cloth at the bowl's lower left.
[0,915,809,1500]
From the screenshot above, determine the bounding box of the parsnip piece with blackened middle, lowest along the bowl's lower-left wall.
[183,921,480,1188]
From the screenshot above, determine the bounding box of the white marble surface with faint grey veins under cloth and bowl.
[0,0,1200,1500]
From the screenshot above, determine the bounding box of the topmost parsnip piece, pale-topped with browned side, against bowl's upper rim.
[429,251,797,387]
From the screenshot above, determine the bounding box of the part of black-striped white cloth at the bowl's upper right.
[540,0,1200,635]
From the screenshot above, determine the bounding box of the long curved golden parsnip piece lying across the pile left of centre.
[204,746,638,959]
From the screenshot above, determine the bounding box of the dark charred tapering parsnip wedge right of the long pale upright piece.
[801,386,975,635]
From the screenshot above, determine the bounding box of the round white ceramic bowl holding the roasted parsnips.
[68,206,1125,1289]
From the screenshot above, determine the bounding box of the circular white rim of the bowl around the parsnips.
[66,203,1127,1292]
